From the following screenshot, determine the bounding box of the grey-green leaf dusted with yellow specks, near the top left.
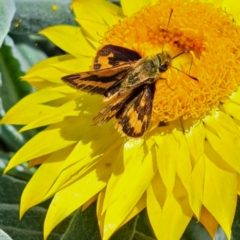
[9,0,77,34]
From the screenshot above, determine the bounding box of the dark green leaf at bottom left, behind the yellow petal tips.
[0,176,70,240]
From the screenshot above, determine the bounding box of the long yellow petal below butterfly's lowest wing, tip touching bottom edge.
[103,140,156,240]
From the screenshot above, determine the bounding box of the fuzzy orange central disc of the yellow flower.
[103,0,240,122]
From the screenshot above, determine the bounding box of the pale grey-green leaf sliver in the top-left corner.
[0,0,16,47]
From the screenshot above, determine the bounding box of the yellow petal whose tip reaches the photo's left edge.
[1,89,64,125]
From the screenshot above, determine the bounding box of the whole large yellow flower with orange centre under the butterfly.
[1,0,240,240]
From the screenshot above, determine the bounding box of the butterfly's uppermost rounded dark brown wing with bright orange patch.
[93,44,141,70]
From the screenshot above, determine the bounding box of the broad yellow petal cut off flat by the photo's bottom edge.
[147,174,192,240]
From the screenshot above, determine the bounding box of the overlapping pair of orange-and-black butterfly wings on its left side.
[62,45,141,95]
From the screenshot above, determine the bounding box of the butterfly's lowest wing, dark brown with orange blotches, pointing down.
[116,84,154,137]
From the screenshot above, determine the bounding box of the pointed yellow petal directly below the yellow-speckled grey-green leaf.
[39,25,96,57]
